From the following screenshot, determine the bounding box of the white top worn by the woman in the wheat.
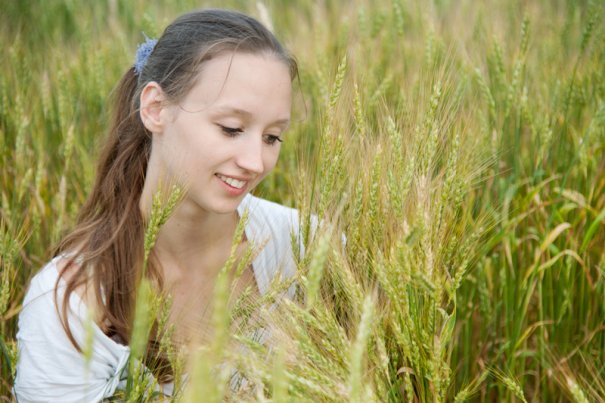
[14,195,303,402]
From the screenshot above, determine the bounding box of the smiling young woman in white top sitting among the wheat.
[14,10,298,402]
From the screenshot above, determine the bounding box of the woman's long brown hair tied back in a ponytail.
[55,10,297,378]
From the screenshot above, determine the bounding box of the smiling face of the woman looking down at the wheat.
[152,52,292,213]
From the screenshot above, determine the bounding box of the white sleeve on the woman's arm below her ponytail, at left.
[13,259,130,402]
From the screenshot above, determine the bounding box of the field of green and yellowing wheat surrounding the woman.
[0,0,605,402]
